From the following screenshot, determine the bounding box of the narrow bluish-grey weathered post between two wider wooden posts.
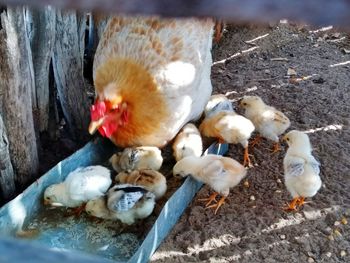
[27,7,56,131]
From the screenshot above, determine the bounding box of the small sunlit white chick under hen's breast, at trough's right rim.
[173,123,203,161]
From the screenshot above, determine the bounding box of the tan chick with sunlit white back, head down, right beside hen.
[199,111,255,166]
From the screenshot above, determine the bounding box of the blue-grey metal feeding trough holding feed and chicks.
[0,139,228,263]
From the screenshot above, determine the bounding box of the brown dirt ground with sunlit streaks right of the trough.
[151,23,350,263]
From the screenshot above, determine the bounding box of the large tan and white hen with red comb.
[89,16,214,147]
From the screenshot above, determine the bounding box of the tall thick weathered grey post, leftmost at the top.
[0,7,39,189]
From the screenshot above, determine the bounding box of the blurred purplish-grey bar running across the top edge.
[0,0,350,27]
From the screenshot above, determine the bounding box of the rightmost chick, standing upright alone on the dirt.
[283,130,322,210]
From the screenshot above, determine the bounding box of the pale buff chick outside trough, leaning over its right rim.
[173,154,247,214]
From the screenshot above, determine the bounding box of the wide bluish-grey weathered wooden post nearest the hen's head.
[53,11,90,142]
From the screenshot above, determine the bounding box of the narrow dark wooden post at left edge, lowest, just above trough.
[0,114,16,200]
